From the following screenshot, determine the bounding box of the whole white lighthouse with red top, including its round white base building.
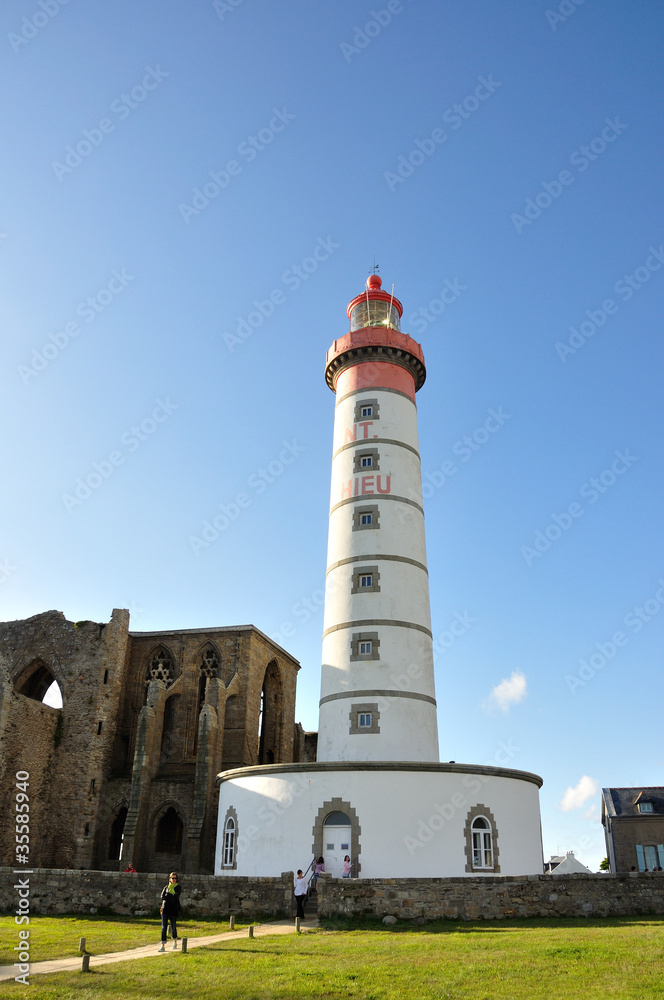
[215,274,543,879]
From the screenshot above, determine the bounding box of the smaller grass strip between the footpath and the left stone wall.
[0,915,247,964]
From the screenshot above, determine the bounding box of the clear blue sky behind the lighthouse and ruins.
[0,0,664,868]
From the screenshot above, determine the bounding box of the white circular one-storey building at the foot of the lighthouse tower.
[215,761,543,878]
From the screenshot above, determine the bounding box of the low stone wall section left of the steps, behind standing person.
[0,868,293,919]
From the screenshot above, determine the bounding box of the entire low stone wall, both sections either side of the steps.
[5,868,664,921]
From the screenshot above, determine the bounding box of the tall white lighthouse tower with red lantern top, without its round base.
[318,274,438,761]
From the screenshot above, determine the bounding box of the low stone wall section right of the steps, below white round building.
[318,872,664,921]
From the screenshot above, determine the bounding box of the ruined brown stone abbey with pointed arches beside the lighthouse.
[0,610,316,873]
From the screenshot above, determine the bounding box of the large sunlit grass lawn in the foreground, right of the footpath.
[3,917,664,1000]
